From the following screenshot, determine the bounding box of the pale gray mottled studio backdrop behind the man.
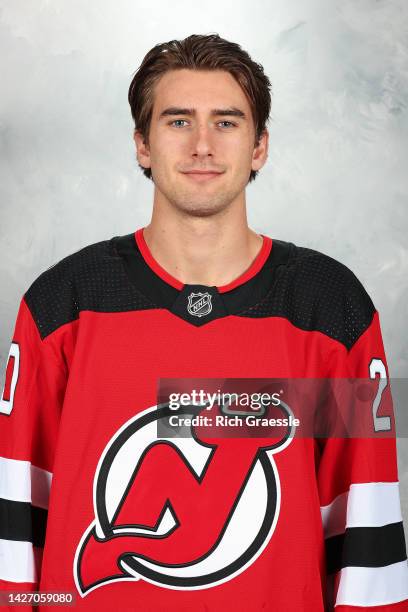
[0,0,408,544]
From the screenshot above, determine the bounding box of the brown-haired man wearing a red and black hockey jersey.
[0,35,408,612]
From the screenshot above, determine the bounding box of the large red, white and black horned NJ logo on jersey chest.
[74,402,294,597]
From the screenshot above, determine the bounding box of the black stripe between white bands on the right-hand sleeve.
[326,522,407,574]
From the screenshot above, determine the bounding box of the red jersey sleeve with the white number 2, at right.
[318,309,408,612]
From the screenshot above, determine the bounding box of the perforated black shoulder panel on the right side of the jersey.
[239,247,375,349]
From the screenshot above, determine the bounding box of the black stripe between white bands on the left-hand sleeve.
[0,499,48,547]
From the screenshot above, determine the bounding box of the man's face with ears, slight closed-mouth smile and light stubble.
[135,69,268,216]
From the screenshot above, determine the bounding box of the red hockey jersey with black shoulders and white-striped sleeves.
[0,228,408,612]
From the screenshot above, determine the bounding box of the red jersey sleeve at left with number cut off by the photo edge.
[0,297,67,610]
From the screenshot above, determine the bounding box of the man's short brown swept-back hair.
[128,34,271,182]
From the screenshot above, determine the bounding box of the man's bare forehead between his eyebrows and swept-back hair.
[153,68,250,115]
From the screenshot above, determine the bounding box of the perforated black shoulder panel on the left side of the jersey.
[24,240,157,338]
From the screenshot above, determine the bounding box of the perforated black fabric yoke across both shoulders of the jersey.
[25,234,375,349]
